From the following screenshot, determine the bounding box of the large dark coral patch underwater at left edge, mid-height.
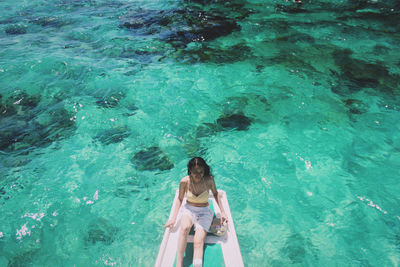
[0,92,75,152]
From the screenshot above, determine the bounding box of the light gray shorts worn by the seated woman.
[180,203,214,232]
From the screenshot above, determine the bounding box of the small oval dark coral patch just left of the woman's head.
[131,147,174,171]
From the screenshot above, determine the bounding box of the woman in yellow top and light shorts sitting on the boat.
[165,157,228,267]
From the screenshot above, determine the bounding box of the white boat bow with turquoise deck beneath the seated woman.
[154,190,244,267]
